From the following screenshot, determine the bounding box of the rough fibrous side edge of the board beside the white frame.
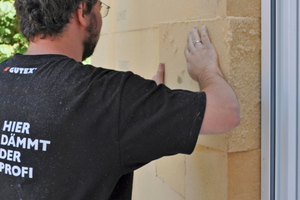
[226,18,261,152]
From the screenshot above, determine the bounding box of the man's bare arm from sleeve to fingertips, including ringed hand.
[185,26,240,134]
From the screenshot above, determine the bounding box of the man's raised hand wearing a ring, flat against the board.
[185,26,222,87]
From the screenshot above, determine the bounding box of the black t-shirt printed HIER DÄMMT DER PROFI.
[0,54,206,200]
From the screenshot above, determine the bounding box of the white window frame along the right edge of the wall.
[261,0,300,200]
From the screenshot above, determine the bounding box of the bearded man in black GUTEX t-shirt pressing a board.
[0,0,240,200]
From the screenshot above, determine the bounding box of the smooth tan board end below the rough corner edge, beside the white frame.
[228,150,260,200]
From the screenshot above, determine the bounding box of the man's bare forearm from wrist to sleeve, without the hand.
[199,68,240,134]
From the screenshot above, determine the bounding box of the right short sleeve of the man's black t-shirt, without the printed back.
[119,74,206,173]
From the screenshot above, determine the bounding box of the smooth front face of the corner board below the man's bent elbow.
[185,145,228,200]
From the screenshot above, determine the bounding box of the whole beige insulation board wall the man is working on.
[92,0,261,200]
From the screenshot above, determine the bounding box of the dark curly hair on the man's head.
[15,0,98,41]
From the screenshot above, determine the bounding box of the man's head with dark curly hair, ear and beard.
[15,0,102,60]
